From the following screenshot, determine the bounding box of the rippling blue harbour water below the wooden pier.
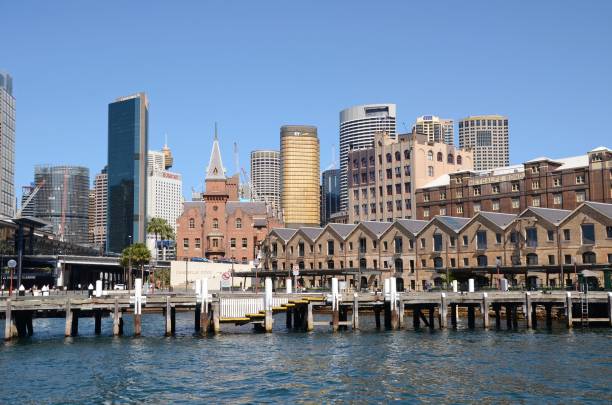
[0,313,612,404]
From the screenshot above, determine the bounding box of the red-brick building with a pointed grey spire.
[176,136,281,262]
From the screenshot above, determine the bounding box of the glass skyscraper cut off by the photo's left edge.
[0,72,15,217]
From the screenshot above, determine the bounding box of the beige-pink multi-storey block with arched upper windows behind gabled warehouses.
[348,133,473,223]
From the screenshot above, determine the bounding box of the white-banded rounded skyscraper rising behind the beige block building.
[340,104,396,210]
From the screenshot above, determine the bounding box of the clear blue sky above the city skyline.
[0,0,612,196]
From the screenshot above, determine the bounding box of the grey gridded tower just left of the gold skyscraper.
[251,150,280,213]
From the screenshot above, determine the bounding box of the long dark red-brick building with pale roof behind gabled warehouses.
[416,147,612,220]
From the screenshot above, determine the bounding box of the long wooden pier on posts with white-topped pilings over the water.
[0,281,612,340]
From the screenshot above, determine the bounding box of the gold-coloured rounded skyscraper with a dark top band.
[280,125,321,228]
